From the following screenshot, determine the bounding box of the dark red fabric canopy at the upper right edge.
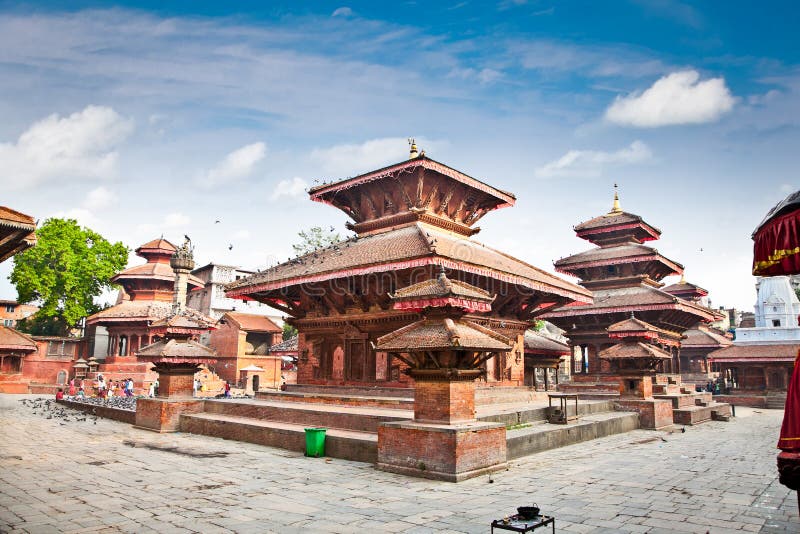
[753,192,800,276]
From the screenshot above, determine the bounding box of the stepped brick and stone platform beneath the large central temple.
[181,388,639,463]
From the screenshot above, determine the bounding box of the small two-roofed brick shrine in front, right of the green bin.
[375,269,513,482]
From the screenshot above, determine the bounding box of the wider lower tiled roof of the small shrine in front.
[376,318,512,352]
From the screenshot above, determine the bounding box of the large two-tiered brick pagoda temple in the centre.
[226,146,592,387]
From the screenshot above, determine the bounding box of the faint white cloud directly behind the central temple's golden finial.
[311,137,432,179]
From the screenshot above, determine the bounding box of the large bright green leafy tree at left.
[9,218,128,335]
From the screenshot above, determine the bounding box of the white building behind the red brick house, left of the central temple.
[186,263,283,327]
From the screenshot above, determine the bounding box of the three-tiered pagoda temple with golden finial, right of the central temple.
[542,193,716,381]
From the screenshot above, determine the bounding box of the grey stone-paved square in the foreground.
[0,395,800,534]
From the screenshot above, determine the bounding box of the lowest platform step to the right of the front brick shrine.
[506,412,639,460]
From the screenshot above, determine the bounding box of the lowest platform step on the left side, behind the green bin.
[181,413,378,463]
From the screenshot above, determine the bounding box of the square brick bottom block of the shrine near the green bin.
[376,421,506,482]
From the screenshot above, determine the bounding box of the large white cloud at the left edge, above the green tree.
[0,106,133,189]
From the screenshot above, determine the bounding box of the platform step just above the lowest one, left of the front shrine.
[204,399,414,432]
